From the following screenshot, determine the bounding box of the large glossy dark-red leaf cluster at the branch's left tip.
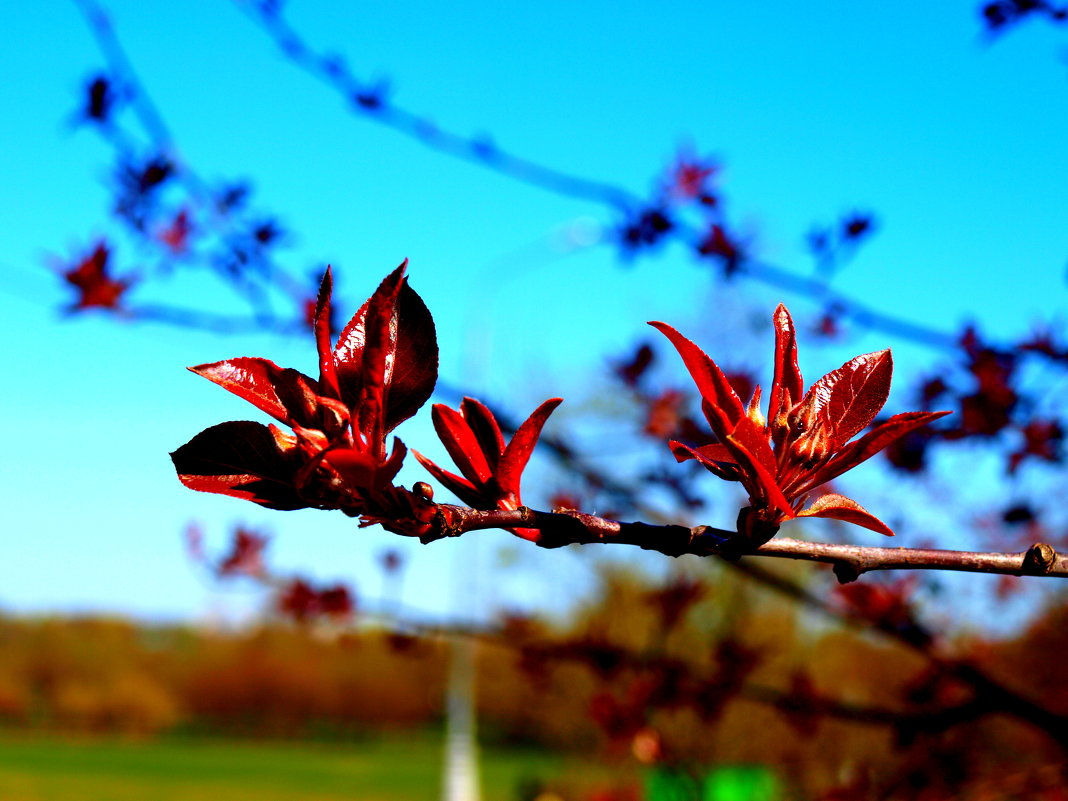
[171,262,438,534]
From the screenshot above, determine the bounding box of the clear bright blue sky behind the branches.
[0,0,1068,617]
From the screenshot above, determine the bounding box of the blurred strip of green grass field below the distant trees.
[0,733,589,801]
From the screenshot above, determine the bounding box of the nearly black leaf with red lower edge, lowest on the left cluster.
[171,421,308,511]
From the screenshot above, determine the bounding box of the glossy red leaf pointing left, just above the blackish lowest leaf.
[189,357,317,428]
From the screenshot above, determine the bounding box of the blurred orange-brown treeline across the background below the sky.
[0,575,1068,788]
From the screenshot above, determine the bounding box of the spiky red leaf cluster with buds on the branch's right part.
[650,304,948,543]
